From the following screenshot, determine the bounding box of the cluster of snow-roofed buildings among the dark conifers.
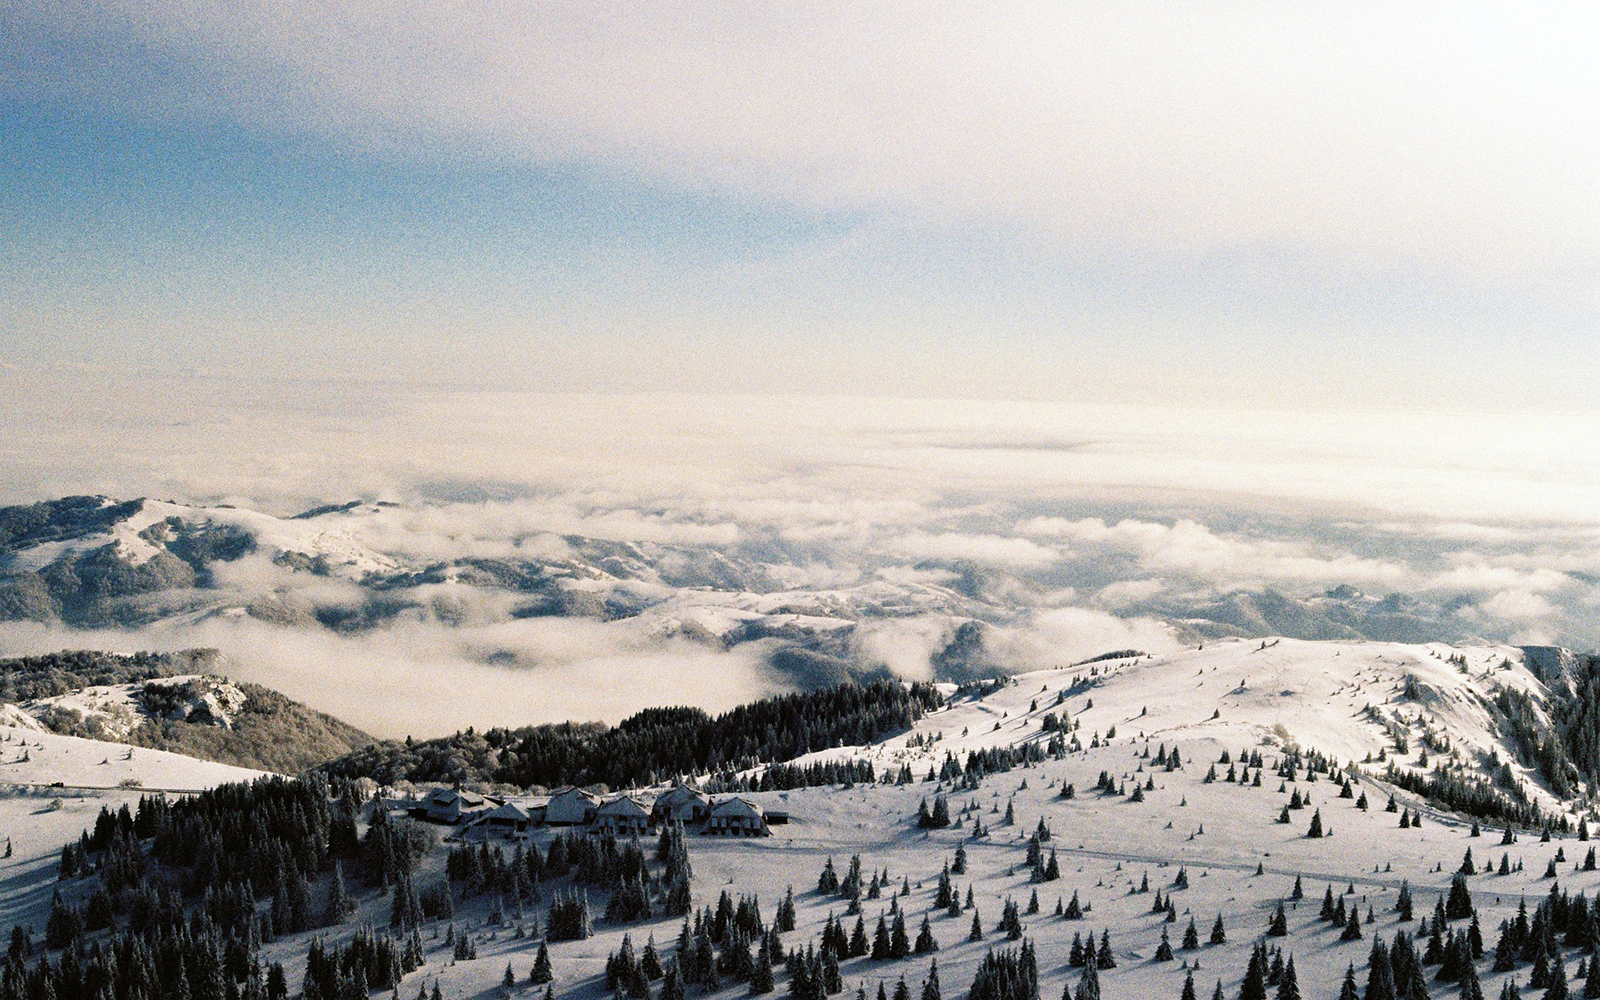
[402,784,789,840]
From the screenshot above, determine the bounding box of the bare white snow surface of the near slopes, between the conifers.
[0,640,1600,1000]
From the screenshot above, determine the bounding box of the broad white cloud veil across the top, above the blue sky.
[11,2,1600,294]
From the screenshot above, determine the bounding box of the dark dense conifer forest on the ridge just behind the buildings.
[322,680,941,787]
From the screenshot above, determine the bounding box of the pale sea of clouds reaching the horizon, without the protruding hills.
[0,366,1600,734]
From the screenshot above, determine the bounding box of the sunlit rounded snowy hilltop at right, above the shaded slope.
[798,638,1560,808]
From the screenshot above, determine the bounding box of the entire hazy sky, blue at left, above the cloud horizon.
[0,0,1600,410]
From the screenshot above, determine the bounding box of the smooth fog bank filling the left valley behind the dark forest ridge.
[3,619,792,736]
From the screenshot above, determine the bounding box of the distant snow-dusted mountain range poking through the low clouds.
[0,496,1523,700]
